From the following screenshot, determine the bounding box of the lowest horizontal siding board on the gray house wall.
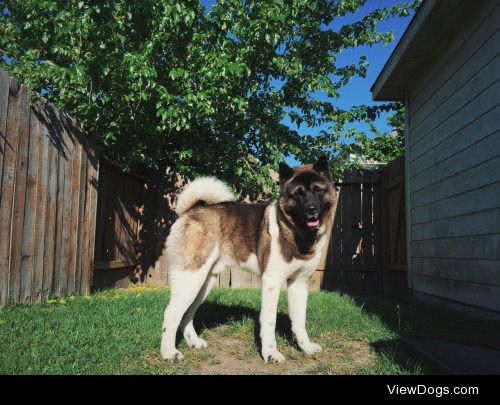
[412,274,500,311]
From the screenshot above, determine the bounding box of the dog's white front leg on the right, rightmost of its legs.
[288,278,322,354]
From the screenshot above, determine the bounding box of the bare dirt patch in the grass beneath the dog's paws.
[124,325,375,375]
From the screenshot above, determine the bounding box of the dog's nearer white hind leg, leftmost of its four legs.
[161,248,219,361]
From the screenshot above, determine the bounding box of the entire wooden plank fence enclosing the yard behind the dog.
[0,65,408,305]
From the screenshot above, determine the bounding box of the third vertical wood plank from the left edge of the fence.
[20,105,41,304]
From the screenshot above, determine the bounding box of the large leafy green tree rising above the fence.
[0,0,418,194]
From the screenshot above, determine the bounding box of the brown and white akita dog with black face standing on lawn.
[161,157,338,363]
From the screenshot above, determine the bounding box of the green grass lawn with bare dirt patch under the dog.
[0,286,496,374]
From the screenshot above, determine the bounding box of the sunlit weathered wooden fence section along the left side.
[0,69,98,305]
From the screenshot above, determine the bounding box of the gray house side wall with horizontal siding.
[406,1,500,311]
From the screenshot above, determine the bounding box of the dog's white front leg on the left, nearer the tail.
[260,273,285,363]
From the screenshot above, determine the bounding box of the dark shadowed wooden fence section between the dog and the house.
[312,158,409,298]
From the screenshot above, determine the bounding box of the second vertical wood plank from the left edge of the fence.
[9,83,30,302]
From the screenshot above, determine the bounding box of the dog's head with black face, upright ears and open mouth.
[279,156,338,231]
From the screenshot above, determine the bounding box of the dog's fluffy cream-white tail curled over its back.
[175,177,235,216]
